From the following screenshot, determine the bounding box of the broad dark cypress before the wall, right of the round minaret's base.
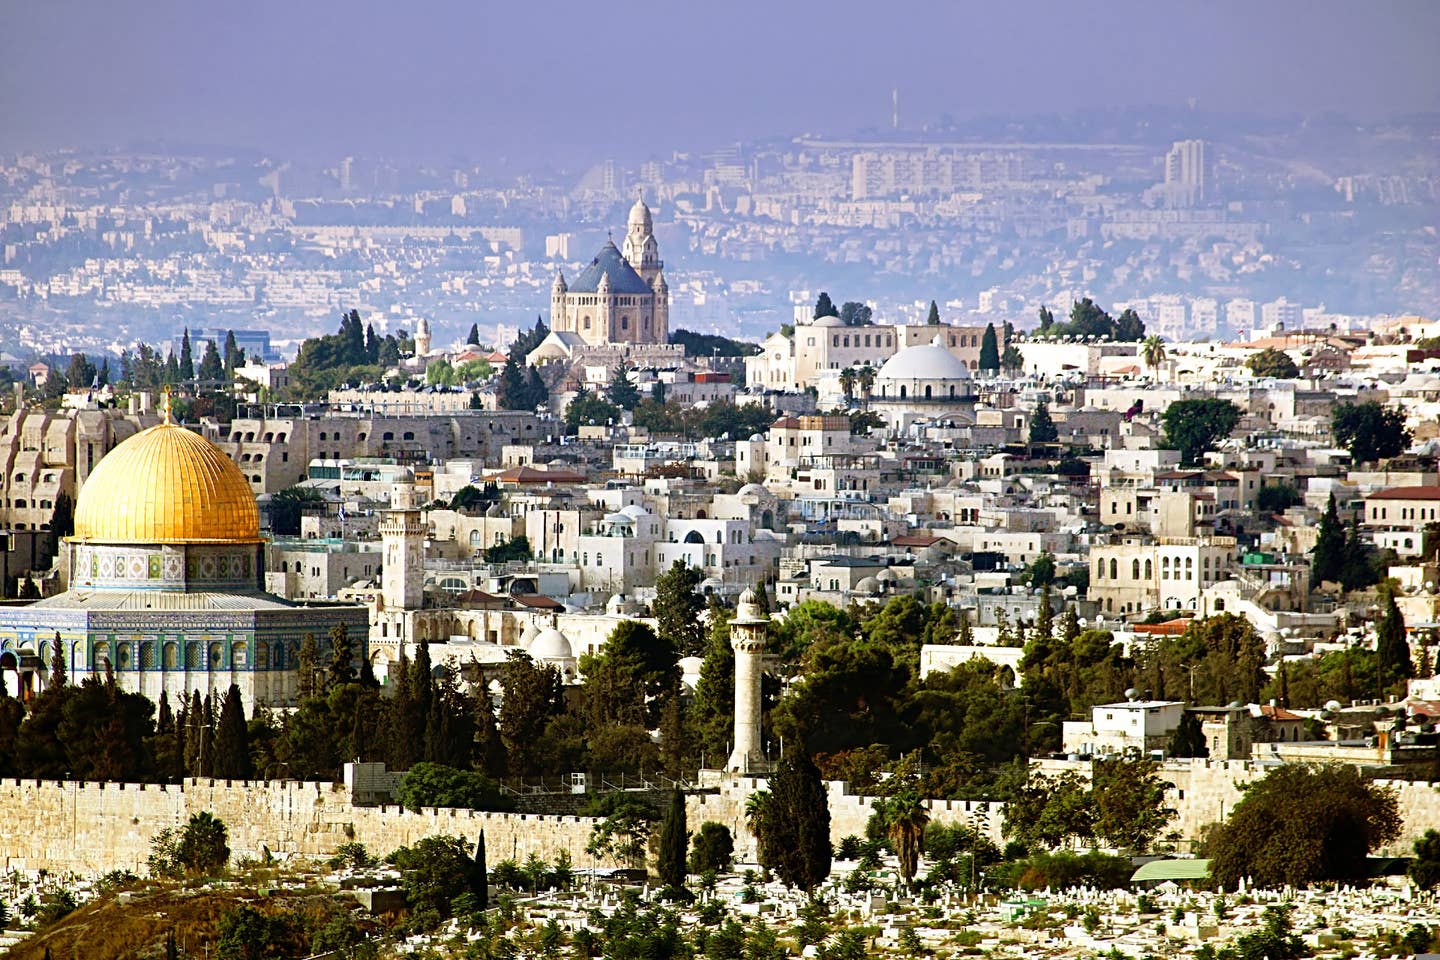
[759,747,831,891]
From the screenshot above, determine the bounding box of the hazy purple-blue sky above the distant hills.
[0,0,1440,161]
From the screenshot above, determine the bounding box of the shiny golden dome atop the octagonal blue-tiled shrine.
[73,420,261,544]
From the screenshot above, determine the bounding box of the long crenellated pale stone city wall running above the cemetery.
[0,760,1440,872]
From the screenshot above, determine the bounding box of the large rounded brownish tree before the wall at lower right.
[1210,763,1400,888]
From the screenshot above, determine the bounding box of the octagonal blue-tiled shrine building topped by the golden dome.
[0,410,367,705]
